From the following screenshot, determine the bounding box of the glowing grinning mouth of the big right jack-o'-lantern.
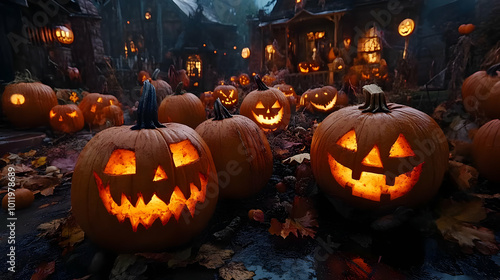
[328,154,424,201]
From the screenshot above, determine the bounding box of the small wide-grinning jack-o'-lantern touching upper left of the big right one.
[300,86,337,113]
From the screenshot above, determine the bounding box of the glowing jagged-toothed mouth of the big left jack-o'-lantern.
[94,172,208,232]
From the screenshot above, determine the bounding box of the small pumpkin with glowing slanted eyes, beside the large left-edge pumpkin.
[49,104,85,133]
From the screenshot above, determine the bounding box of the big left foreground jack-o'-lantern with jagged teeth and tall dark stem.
[71,81,218,252]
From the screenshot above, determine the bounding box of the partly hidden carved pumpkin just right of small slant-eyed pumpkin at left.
[78,93,120,128]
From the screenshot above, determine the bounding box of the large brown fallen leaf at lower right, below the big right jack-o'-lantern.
[436,199,500,255]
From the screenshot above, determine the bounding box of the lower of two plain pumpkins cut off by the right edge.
[472,120,500,182]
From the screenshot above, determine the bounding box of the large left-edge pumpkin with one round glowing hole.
[2,82,57,128]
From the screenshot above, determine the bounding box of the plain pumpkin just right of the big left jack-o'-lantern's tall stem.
[158,82,206,129]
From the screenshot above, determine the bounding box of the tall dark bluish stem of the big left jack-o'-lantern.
[130,80,165,130]
